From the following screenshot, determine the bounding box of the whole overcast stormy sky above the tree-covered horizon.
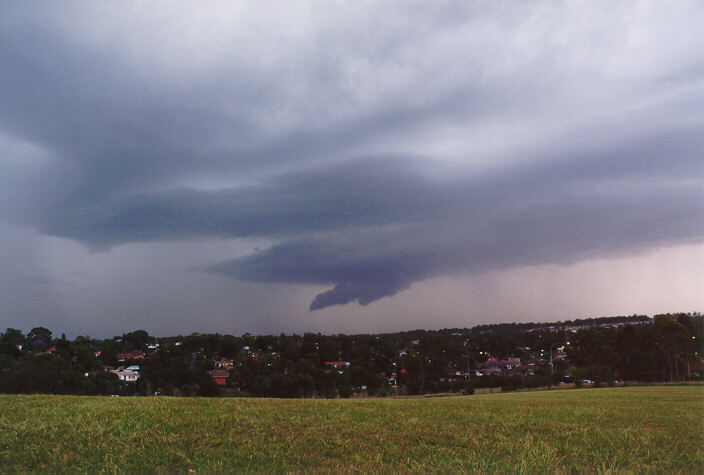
[0,0,704,337]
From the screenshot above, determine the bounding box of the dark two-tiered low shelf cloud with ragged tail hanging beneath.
[17,122,704,310]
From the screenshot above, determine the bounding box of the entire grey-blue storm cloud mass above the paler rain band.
[0,2,704,310]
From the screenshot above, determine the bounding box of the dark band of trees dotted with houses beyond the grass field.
[0,313,703,397]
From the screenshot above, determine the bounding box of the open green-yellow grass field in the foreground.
[0,386,704,472]
